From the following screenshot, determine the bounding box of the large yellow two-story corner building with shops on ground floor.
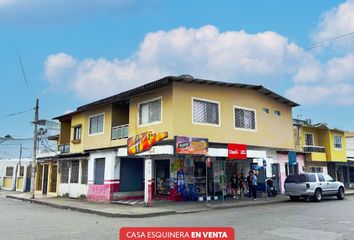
[56,76,297,202]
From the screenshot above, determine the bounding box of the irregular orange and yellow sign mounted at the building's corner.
[127,131,168,155]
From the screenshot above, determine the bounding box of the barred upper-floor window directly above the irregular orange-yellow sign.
[138,99,162,125]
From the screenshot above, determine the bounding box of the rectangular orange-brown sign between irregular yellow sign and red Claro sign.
[176,136,208,155]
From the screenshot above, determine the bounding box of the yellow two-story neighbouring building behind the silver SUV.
[294,119,347,184]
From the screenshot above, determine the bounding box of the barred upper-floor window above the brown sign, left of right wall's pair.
[193,99,220,125]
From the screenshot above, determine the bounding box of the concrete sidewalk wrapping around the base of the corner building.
[0,190,354,218]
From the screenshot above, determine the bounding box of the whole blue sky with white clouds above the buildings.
[0,0,354,141]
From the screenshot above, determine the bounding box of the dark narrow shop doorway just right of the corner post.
[155,160,170,195]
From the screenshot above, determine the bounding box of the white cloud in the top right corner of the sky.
[312,0,354,50]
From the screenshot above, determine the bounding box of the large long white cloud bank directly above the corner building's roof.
[45,25,308,100]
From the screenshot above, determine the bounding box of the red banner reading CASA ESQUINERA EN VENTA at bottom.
[119,227,236,240]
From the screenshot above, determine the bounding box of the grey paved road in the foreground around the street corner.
[0,197,354,240]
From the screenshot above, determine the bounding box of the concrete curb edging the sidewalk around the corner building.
[6,192,354,218]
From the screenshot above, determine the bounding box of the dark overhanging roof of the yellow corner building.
[54,75,299,120]
